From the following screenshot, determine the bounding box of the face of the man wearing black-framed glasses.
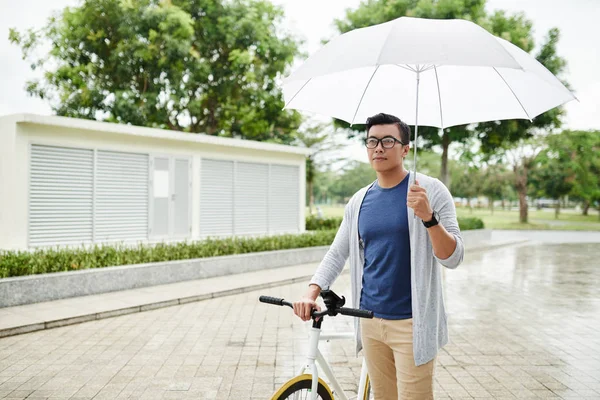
[367,124,410,172]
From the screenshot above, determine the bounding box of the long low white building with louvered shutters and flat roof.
[0,114,309,249]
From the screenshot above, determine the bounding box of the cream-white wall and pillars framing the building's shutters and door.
[0,118,306,249]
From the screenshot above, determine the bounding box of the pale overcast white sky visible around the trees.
[0,0,600,161]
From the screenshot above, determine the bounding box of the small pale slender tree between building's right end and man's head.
[293,123,340,214]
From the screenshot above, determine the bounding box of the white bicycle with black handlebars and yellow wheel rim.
[259,290,373,400]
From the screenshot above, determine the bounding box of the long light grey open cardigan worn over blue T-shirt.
[311,173,464,365]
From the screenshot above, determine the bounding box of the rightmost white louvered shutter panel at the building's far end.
[269,165,300,233]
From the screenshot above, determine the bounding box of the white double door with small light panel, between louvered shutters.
[150,156,191,240]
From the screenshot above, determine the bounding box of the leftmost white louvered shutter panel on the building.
[29,144,94,247]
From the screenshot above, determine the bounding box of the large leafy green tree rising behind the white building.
[9,0,301,143]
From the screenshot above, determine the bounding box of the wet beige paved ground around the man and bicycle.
[0,236,600,399]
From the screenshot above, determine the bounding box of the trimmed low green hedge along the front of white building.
[0,230,336,278]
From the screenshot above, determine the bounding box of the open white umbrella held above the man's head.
[283,17,575,176]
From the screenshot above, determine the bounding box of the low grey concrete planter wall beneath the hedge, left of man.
[0,246,329,310]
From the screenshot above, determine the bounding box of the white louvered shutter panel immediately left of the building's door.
[95,151,149,242]
